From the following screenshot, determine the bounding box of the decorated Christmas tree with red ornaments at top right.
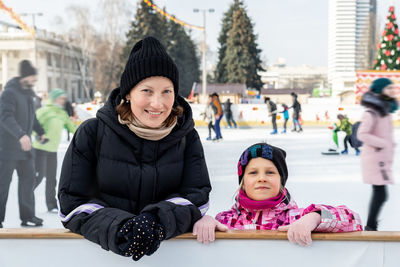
[374,6,400,70]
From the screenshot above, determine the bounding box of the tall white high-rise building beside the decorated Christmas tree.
[328,0,376,95]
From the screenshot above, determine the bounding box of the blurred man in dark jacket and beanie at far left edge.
[0,60,46,228]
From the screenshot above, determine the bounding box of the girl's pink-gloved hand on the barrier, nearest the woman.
[193,215,228,244]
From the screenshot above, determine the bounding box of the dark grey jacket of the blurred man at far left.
[0,77,44,160]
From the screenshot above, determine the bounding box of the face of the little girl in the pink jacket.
[243,158,281,201]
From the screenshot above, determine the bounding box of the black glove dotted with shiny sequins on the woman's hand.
[118,213,165,261]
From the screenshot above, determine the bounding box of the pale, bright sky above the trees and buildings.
[0,0,400,66]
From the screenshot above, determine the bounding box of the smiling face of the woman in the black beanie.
[126,76,175,128]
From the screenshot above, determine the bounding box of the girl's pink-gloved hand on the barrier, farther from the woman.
[278,212,321,247]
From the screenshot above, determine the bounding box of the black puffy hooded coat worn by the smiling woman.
[58,88,211,254]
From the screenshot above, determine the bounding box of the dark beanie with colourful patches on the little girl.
[238,143,288,187]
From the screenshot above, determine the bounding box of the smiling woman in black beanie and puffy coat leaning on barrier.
[58,37,211,260]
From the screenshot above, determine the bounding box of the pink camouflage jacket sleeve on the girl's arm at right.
[289,204,363,232]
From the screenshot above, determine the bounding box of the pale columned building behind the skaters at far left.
[0,23,93,103]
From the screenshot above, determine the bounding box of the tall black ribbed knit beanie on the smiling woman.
[120,36,179,99]
